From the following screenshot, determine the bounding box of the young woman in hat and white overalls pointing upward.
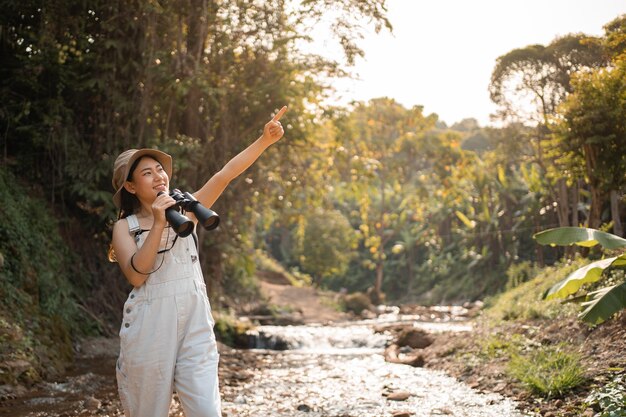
[112,107,287,417]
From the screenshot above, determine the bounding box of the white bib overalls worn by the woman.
[116,215,222,417]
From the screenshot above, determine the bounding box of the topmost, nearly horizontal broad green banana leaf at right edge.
[533,227,626,249]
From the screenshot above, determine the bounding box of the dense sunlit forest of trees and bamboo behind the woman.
[0,0,626,412]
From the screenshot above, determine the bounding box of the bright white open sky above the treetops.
[324,0,626,126]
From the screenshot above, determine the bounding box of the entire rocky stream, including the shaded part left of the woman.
[0,311,524,417]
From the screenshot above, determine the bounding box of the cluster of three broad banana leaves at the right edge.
[535,227,626,324]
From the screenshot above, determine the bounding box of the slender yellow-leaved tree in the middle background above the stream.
[335,98,436,302]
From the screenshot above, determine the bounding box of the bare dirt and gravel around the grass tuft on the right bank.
[416,312,626,417]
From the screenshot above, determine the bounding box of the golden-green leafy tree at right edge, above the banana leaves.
[554,60,626,232]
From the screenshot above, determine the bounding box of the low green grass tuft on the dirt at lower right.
[507,345,585,398]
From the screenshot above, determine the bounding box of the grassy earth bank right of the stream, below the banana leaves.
[426,260,626,417]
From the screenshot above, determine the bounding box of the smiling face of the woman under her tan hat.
[124,156,170,204]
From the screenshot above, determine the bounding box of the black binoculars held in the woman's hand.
[158,189,220,237]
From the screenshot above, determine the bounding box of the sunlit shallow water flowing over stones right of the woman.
[223,313,523,417]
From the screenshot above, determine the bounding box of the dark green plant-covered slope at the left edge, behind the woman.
[0,168,97,384]
